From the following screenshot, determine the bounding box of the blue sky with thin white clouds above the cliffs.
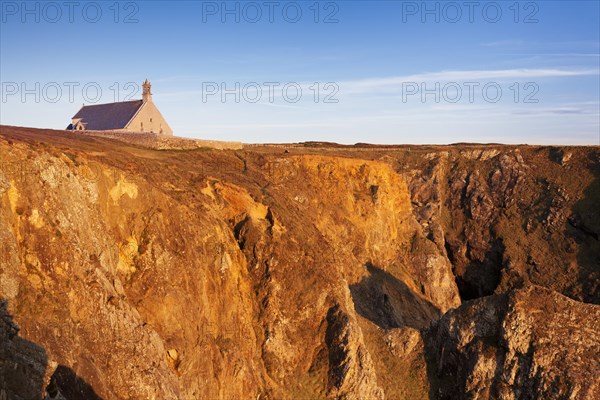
[0,0,600,145]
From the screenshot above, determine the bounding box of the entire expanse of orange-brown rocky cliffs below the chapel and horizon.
[0,127,600,399]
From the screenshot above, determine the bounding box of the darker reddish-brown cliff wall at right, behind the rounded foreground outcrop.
[402,146,600,304]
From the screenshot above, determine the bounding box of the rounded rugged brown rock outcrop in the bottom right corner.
[426,286,600,399]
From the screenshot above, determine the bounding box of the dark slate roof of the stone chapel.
[67,100,144,131]
